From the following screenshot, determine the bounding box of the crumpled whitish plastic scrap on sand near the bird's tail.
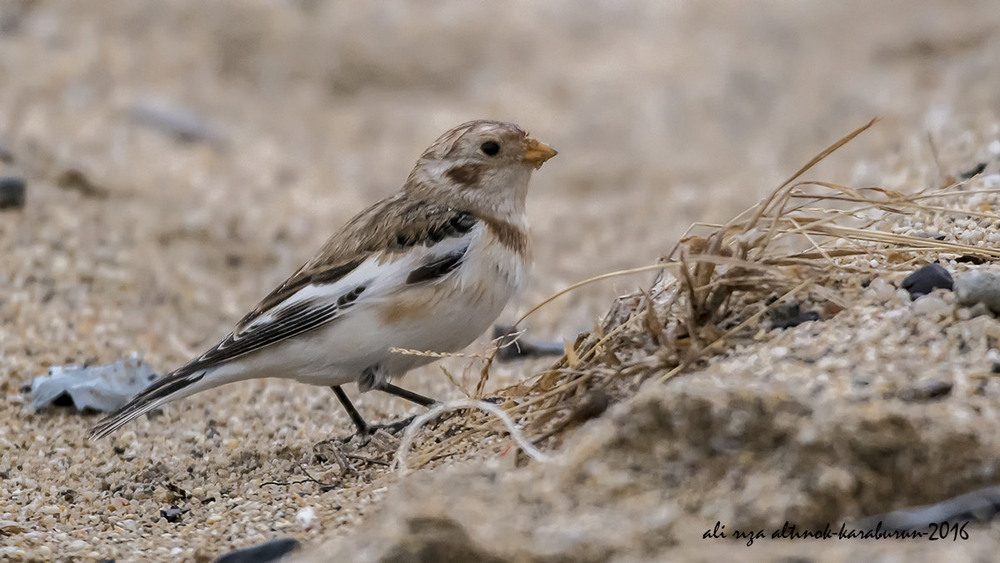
[31,356,156,412]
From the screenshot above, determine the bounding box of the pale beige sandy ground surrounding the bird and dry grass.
[0,0,1000,561]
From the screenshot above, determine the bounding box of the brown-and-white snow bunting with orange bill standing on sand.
[90,121,556,438]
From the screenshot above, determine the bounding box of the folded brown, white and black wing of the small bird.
[178,195,477,373]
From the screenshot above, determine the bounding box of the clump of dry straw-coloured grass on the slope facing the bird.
[392,119,1000,468]
